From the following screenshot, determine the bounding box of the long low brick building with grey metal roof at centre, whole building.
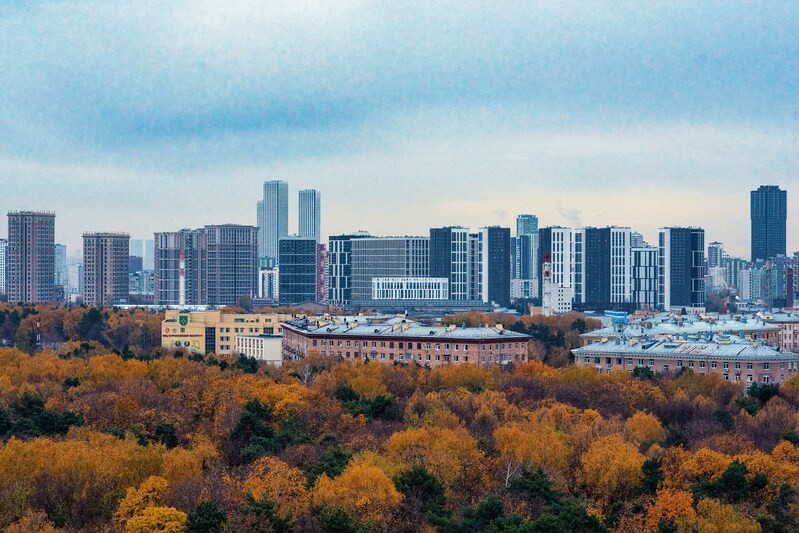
[283,316,531,367]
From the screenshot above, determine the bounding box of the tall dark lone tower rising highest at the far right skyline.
[750,185,788,262]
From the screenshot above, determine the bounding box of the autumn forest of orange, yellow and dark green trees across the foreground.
[0,304,799,533]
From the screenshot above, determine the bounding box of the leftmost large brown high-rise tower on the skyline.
[6,211,55,303]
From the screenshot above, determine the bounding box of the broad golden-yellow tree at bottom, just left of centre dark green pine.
[312,461,402,529]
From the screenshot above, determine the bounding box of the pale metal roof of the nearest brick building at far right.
[572,335,799,361]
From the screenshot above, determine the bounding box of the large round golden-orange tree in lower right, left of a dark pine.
[579,435,644,504]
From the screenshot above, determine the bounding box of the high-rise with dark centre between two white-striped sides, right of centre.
[574,227,632,310]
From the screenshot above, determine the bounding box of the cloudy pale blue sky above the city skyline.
[0,0,799,257]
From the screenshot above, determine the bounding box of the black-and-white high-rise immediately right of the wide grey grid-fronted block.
[430,226,469,300]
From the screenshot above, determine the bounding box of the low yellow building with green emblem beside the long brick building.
[161,310,303,355]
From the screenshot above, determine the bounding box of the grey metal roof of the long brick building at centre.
[283,316,530,340]
